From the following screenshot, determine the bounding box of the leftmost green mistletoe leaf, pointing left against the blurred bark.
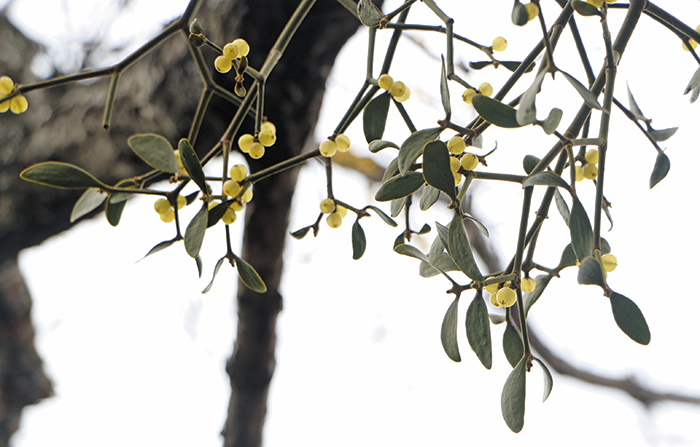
[19,161,109,189]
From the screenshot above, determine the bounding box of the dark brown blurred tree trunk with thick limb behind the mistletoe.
[0,0,370,447]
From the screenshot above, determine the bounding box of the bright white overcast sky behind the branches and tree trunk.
[8,0,700,447]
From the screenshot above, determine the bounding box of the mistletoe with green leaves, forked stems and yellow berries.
[6,0,700,432]
